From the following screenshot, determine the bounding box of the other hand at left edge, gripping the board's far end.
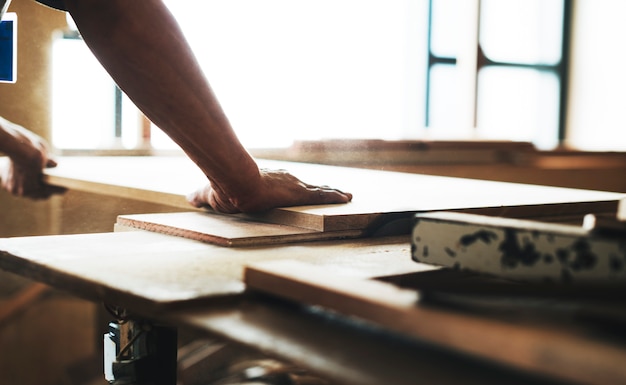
[0,117,65,199]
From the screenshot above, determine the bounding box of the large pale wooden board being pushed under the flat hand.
[46,157,623,231]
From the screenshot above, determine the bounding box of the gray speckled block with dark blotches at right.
[411,212,626,284]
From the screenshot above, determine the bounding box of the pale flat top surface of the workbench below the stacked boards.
[0,231,426,313]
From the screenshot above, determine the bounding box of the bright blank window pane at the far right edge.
[567,0,626,151]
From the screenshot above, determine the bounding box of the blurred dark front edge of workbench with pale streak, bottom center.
[171,296,562,385]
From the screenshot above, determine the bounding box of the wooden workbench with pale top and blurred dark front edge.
[0,231,576,385]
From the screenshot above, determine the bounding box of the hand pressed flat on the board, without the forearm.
[187,169,352,214]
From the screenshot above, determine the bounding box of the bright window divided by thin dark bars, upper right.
[425,0,569,148]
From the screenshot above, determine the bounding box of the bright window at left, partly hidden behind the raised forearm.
[51,27,144,150]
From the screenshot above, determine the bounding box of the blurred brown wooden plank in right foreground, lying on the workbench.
[245,260,626,385]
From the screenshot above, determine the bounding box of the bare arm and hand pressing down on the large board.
[65,0,352,212]
